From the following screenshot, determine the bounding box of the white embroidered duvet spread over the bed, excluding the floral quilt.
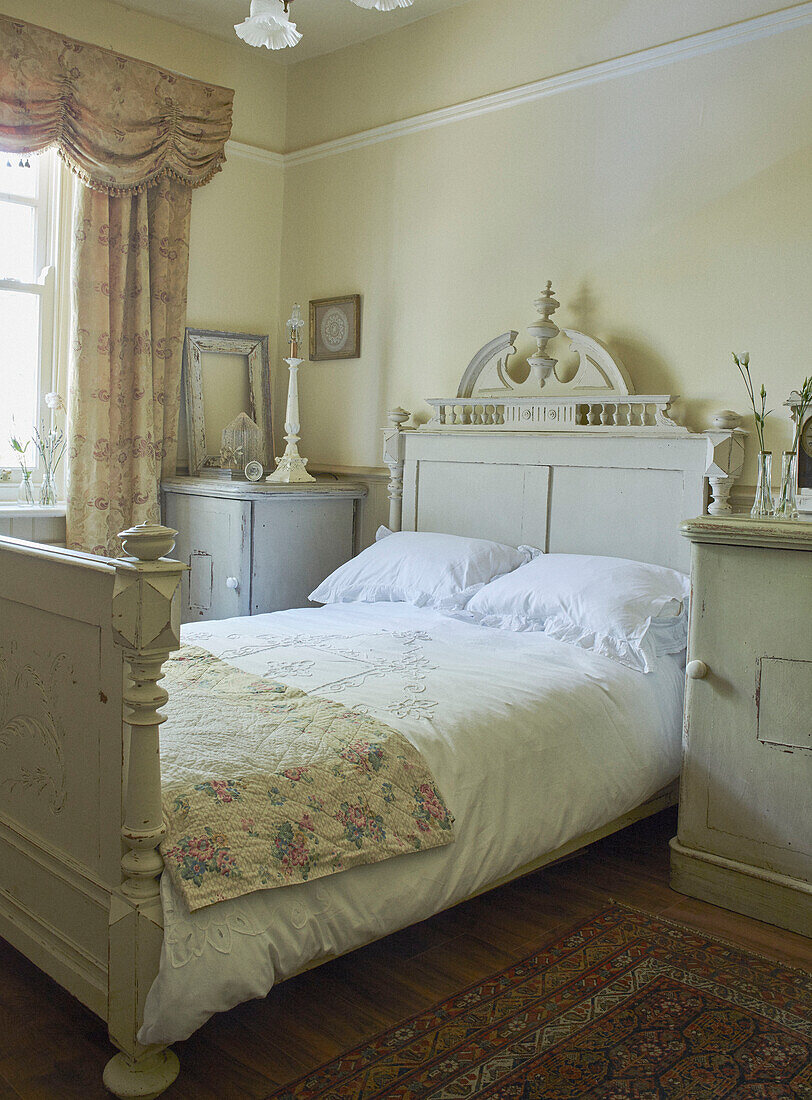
[139,603,683,1044]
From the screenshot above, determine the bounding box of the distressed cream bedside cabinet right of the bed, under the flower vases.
[671,516,812,935]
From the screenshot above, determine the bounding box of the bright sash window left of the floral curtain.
[0,152,56,481]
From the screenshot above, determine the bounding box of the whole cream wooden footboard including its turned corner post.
[0,527,183,1095]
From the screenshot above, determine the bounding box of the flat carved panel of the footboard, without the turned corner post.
[0,539,123,1016]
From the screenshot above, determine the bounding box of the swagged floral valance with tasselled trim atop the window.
[0,15,234,195]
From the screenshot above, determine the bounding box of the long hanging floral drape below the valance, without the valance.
[67,177,191,557]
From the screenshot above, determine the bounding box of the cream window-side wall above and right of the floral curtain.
[0,0,286,461]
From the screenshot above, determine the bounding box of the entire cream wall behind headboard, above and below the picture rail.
[277,0,812,482]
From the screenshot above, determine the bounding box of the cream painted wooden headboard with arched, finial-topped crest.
[384,283,745,572]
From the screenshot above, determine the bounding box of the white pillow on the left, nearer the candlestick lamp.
[310,527,539,611]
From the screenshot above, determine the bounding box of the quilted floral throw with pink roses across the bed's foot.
[155,646,453,911]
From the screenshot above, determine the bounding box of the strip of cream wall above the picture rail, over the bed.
[286,0,783,150]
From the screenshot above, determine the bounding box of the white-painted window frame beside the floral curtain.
[0,149,62,490]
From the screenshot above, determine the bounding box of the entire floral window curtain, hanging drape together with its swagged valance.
[0,15,234,556]
